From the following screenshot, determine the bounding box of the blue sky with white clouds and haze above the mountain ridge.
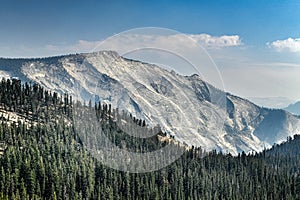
[0,0,300,106]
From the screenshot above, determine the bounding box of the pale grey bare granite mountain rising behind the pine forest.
[0,51,300,155]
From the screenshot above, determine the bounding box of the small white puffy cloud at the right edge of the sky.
[267,38,300,53]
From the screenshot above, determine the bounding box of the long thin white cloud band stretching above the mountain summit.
[46,34,242,54]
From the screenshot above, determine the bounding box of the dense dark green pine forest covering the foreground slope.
[0,79,300,200]
